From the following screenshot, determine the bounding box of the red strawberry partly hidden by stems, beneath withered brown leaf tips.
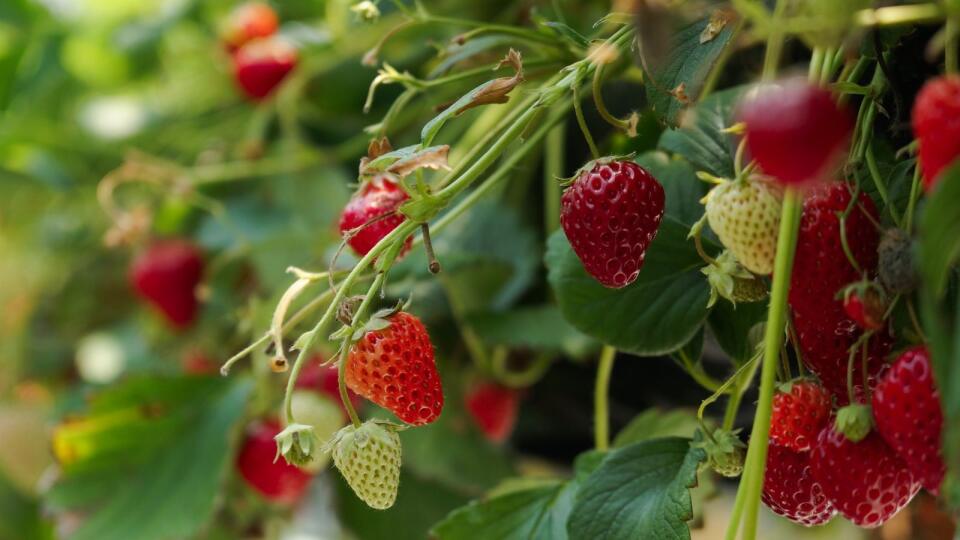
[340,176,413,257]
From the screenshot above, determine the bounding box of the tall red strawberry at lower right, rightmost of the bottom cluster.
[873,347,946,494]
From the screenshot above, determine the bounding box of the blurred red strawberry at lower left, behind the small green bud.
[236,420,312,504]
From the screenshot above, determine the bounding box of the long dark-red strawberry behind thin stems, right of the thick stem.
[789,183,892,404]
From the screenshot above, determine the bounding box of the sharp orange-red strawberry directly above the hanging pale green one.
[346,311,443,426]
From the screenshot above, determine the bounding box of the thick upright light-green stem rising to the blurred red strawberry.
[731,188,802,540]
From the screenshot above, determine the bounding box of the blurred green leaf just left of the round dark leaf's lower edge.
[467,304,598,357]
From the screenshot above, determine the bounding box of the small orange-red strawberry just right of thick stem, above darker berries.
[770,381,831,452]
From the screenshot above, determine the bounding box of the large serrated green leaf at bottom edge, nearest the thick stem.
[567,438,706,540]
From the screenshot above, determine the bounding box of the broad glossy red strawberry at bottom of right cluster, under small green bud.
[810,425,920,528]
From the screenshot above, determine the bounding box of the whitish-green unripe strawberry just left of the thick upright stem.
[705,175,782,275]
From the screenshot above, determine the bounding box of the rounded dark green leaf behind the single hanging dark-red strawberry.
[546,217,710,356]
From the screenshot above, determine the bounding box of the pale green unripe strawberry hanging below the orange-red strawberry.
[329,420,400,510]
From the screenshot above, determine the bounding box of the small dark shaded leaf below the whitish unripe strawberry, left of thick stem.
[707,300,767,365]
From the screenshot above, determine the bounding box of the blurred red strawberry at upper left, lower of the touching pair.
[233,37,297,101]
